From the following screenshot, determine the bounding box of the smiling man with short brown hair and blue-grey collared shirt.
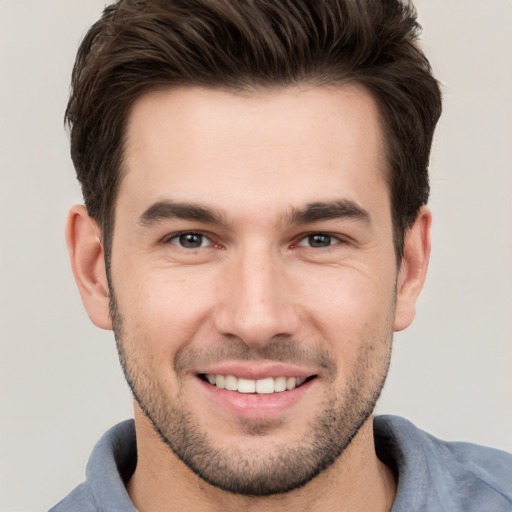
[53,0,512,511]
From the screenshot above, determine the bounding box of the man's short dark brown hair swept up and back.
[66,0,441,263]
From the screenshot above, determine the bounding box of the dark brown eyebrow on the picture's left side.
[137,201,227,227]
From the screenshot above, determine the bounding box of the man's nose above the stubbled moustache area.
[214,245,300,346]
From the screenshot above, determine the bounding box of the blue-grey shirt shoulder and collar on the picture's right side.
[375,416,512,512]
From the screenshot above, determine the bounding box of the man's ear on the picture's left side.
[66,205,112,329]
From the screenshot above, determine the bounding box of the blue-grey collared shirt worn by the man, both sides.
[50,416,512,512]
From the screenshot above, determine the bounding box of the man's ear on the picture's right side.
[394,206,432,331]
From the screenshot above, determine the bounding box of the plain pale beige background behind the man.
[0,0,512,512]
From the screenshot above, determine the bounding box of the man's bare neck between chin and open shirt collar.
[127,408,396,512]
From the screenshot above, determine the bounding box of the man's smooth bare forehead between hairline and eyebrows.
[118,86,388,223]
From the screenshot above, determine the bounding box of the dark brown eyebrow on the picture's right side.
[289,199,370,224]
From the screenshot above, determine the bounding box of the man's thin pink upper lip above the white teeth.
[195,361,318,380]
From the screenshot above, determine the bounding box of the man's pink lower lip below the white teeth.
[197,377,316,419]
